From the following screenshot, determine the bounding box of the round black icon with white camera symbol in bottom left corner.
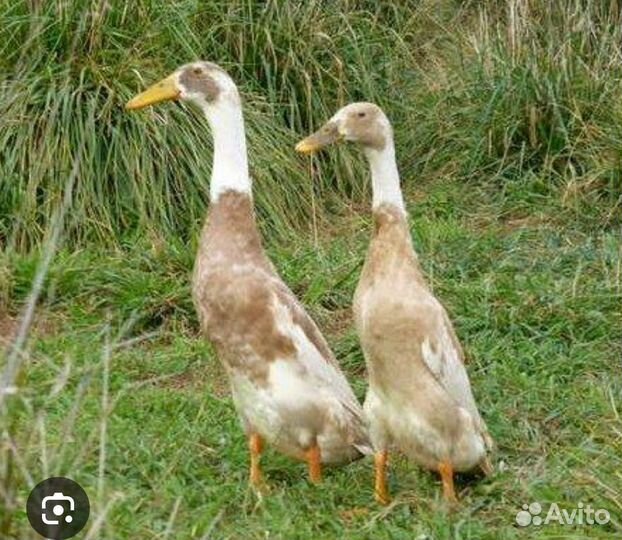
[26,476,91,540]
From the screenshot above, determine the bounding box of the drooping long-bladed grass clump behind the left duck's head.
[0,0,422,249]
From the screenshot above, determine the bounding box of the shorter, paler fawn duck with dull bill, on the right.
[296,102,494,504]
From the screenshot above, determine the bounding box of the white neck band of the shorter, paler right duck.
[365,137,406,214]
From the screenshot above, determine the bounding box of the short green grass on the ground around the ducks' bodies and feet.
[2,179,622,538]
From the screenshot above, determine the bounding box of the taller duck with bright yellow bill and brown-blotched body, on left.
[126,61,372,487]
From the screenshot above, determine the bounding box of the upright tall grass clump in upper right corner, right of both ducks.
[413,0,622,214]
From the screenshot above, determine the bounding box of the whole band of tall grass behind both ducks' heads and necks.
[0,0,622,251]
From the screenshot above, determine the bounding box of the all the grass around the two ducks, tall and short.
[0,0,622,540]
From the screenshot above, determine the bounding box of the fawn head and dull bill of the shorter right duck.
[296,102,393,154]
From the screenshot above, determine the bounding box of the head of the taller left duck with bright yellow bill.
[125,61,240,112]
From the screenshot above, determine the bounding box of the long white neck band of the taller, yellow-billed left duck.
[203,101,252,202]
